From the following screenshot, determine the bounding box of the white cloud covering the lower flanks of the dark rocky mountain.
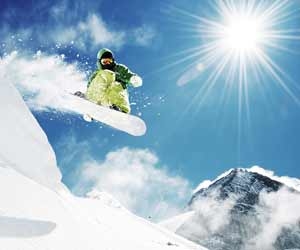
[176,185,300,250]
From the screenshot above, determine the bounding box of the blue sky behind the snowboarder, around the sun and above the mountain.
[0,0,300,219]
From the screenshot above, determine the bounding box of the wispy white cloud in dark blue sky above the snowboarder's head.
[46,13,156,50]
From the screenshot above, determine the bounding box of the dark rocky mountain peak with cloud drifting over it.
[161,168,300,250]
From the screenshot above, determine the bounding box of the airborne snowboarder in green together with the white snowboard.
[74,48,146,135]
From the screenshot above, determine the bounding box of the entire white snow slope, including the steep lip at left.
[0,76,204,250]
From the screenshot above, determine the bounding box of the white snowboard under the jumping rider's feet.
[68,93,147,136]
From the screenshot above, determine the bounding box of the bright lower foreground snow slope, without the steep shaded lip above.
[0,165,202,250]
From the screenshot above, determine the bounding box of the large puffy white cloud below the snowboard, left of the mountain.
[75,147,191,220]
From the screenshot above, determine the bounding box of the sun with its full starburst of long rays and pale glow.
[160,0,300,154]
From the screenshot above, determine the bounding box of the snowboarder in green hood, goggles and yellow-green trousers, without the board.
[75,48,143,113]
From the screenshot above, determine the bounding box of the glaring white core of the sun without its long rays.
[203,1,279,65]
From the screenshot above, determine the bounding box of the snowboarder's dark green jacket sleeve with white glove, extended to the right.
[115,64,142,87]
